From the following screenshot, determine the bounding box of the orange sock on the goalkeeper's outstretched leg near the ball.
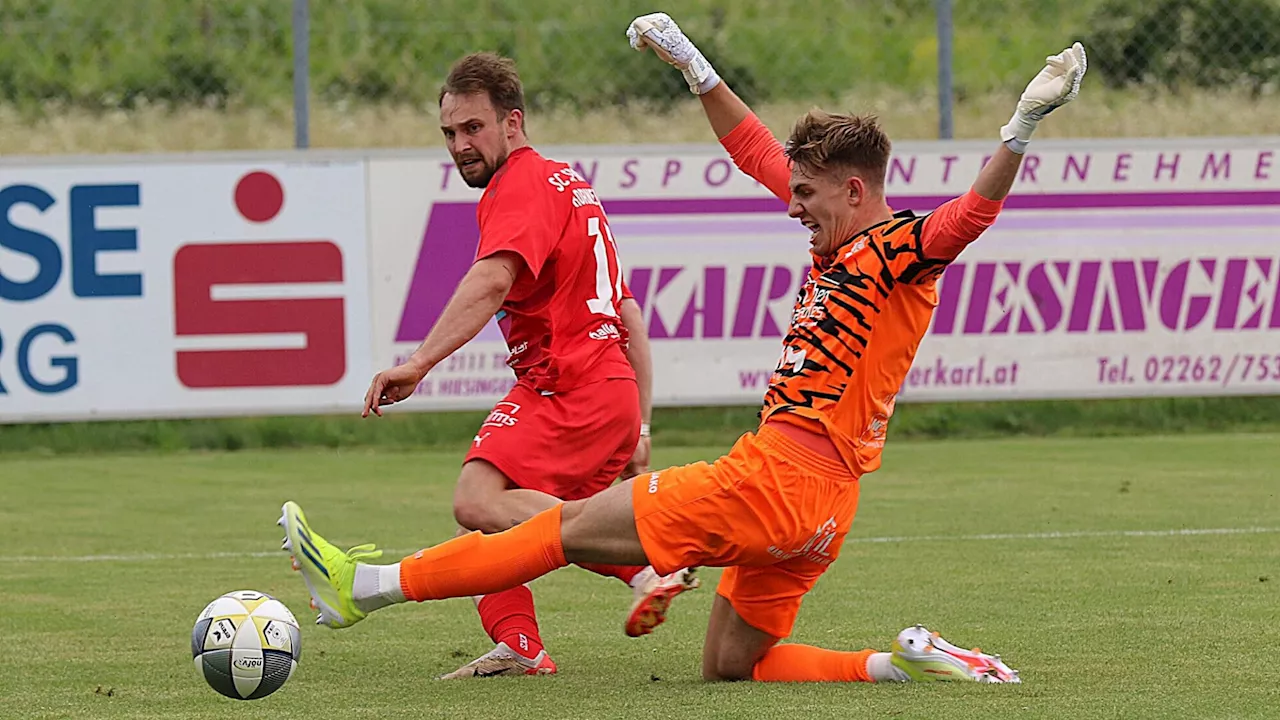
[401,505,568,602]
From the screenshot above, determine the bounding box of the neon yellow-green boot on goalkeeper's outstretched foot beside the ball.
[276,500,383,629]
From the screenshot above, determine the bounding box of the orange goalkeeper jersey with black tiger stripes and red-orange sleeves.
[721,115,1002,475]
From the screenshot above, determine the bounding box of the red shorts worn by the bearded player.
[463,378,640,500]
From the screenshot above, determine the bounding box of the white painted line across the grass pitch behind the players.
[0,528,1280,564]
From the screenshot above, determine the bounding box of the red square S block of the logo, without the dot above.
[173,241,347,388]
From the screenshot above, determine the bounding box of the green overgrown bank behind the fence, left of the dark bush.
[0,0,1100,108]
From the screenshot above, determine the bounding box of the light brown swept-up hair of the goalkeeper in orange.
[786,108,892,187]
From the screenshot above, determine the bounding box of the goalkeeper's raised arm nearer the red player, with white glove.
[627,13,791,202]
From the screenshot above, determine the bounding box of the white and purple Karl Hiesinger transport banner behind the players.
[370,138,1280,409]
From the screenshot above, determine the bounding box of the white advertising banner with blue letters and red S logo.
[0,160,372,423]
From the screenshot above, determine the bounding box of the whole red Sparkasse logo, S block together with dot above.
[173,170,347,388]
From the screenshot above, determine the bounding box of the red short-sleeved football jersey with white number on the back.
[476,147,635,392]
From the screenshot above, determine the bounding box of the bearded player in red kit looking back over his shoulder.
[362,53,698,679]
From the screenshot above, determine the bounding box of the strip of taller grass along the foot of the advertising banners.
[0,397,1280,455]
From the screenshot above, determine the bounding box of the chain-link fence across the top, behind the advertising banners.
[0,0,1280,150]
